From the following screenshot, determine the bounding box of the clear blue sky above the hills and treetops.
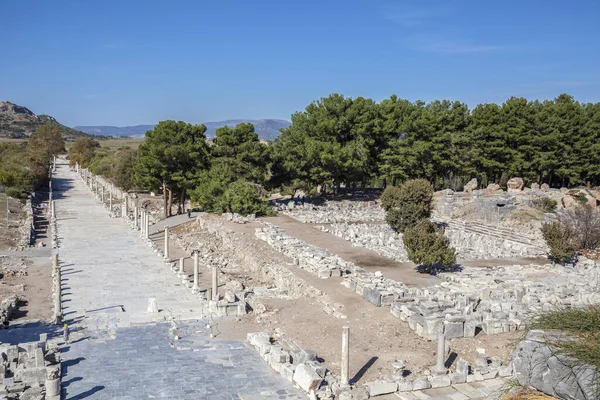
[0,0,600,126]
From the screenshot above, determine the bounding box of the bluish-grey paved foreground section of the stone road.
[63,323,306,400]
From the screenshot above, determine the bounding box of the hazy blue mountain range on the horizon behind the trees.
[74,119,291,140]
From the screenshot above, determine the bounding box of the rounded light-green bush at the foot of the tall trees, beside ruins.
[219,180,270,216]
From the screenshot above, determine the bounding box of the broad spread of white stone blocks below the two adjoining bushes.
[343,260,600,340]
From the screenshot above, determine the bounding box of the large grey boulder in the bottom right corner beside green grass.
[512,330,600,400]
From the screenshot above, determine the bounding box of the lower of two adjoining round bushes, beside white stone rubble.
[402,219,456,273]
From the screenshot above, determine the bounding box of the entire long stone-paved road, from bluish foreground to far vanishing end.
[53,164,305,400]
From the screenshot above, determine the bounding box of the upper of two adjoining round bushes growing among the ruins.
[381,179,433,232]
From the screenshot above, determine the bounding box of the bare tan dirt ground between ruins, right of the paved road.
[166,216,518,382]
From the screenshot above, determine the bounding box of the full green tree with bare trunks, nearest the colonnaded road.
[134,121,209,218]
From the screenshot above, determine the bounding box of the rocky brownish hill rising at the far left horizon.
[0,101,90,140]
